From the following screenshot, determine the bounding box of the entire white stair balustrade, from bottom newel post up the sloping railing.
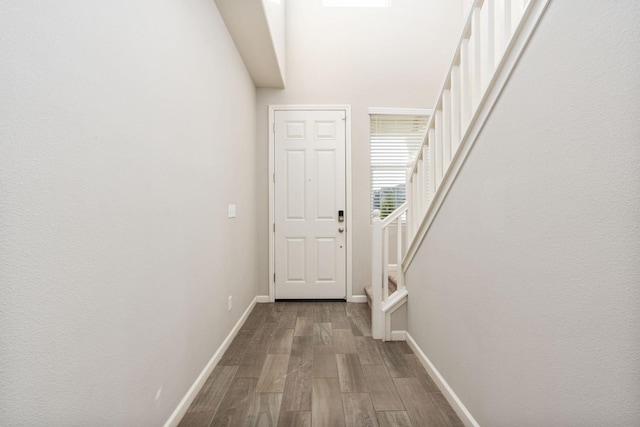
[365,0,549,341]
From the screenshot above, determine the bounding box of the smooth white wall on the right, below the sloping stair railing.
[407,0,640,426]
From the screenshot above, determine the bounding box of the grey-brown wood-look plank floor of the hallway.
[180,302,463,427]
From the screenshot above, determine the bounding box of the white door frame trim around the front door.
[267,105,353,302]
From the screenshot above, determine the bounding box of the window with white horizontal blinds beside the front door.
[369,108,431,218]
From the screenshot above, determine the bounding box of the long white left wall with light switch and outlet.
[0,0,257,426]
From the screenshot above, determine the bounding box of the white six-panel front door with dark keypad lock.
[274,111,348,299]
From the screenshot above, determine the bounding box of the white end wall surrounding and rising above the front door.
[257,0,463,295]
